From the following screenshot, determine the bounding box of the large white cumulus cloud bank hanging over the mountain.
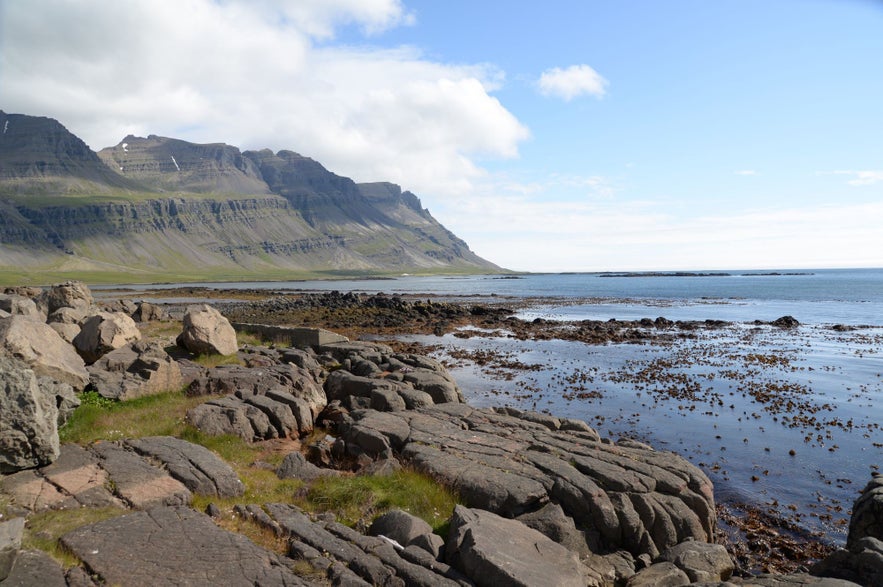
[0,0,528,194]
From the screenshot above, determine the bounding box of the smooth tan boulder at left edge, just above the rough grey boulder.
[0,316,89,391]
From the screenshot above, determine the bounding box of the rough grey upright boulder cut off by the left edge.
[0,354,61,474]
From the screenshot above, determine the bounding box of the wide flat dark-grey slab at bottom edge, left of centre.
[61,506,309,587]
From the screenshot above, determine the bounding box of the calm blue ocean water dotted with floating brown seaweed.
[96,269,883,543]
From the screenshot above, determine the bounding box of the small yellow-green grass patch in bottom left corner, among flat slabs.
[22,507,127,568]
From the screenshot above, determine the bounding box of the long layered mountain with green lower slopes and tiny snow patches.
[0,111,501,283]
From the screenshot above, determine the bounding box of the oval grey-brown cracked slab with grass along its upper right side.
[126,436,245,498]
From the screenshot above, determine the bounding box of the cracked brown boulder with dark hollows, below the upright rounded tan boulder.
[88,341,184,400]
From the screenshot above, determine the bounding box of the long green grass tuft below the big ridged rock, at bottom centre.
[296,469,460,532]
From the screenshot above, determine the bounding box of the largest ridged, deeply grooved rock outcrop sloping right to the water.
[339,404,715,559]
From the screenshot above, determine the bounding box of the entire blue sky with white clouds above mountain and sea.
[0,0,883,272]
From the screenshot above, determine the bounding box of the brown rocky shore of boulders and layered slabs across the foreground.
[0,282,883,587]
